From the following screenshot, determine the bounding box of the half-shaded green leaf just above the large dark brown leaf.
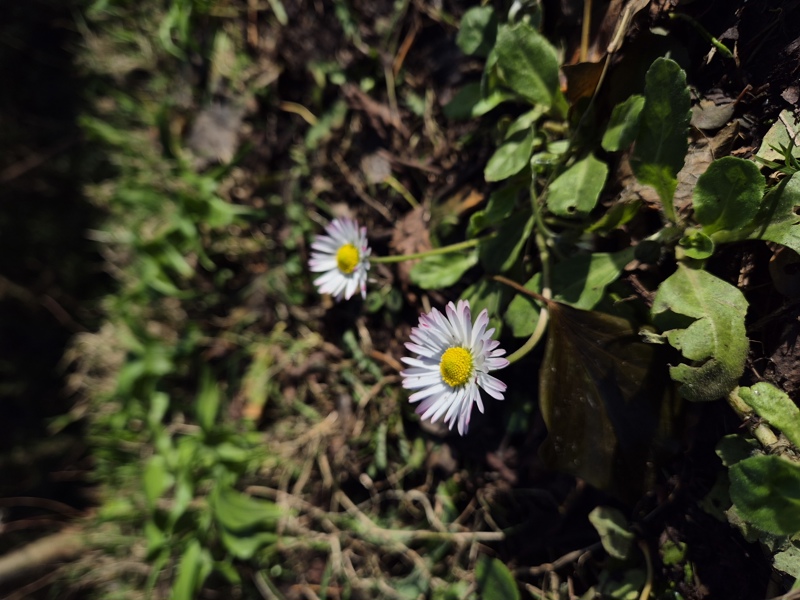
[552,247,635,310]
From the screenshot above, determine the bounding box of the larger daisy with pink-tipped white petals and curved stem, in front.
[400,300,508,435]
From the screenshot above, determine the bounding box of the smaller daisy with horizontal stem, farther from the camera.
[308,218,372,300]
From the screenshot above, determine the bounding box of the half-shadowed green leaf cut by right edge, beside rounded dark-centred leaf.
[749,173,800,252]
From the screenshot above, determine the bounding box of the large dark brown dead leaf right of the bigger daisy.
[539,301,675,501]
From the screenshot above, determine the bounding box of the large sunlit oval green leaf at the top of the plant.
[493,23,561,108]
